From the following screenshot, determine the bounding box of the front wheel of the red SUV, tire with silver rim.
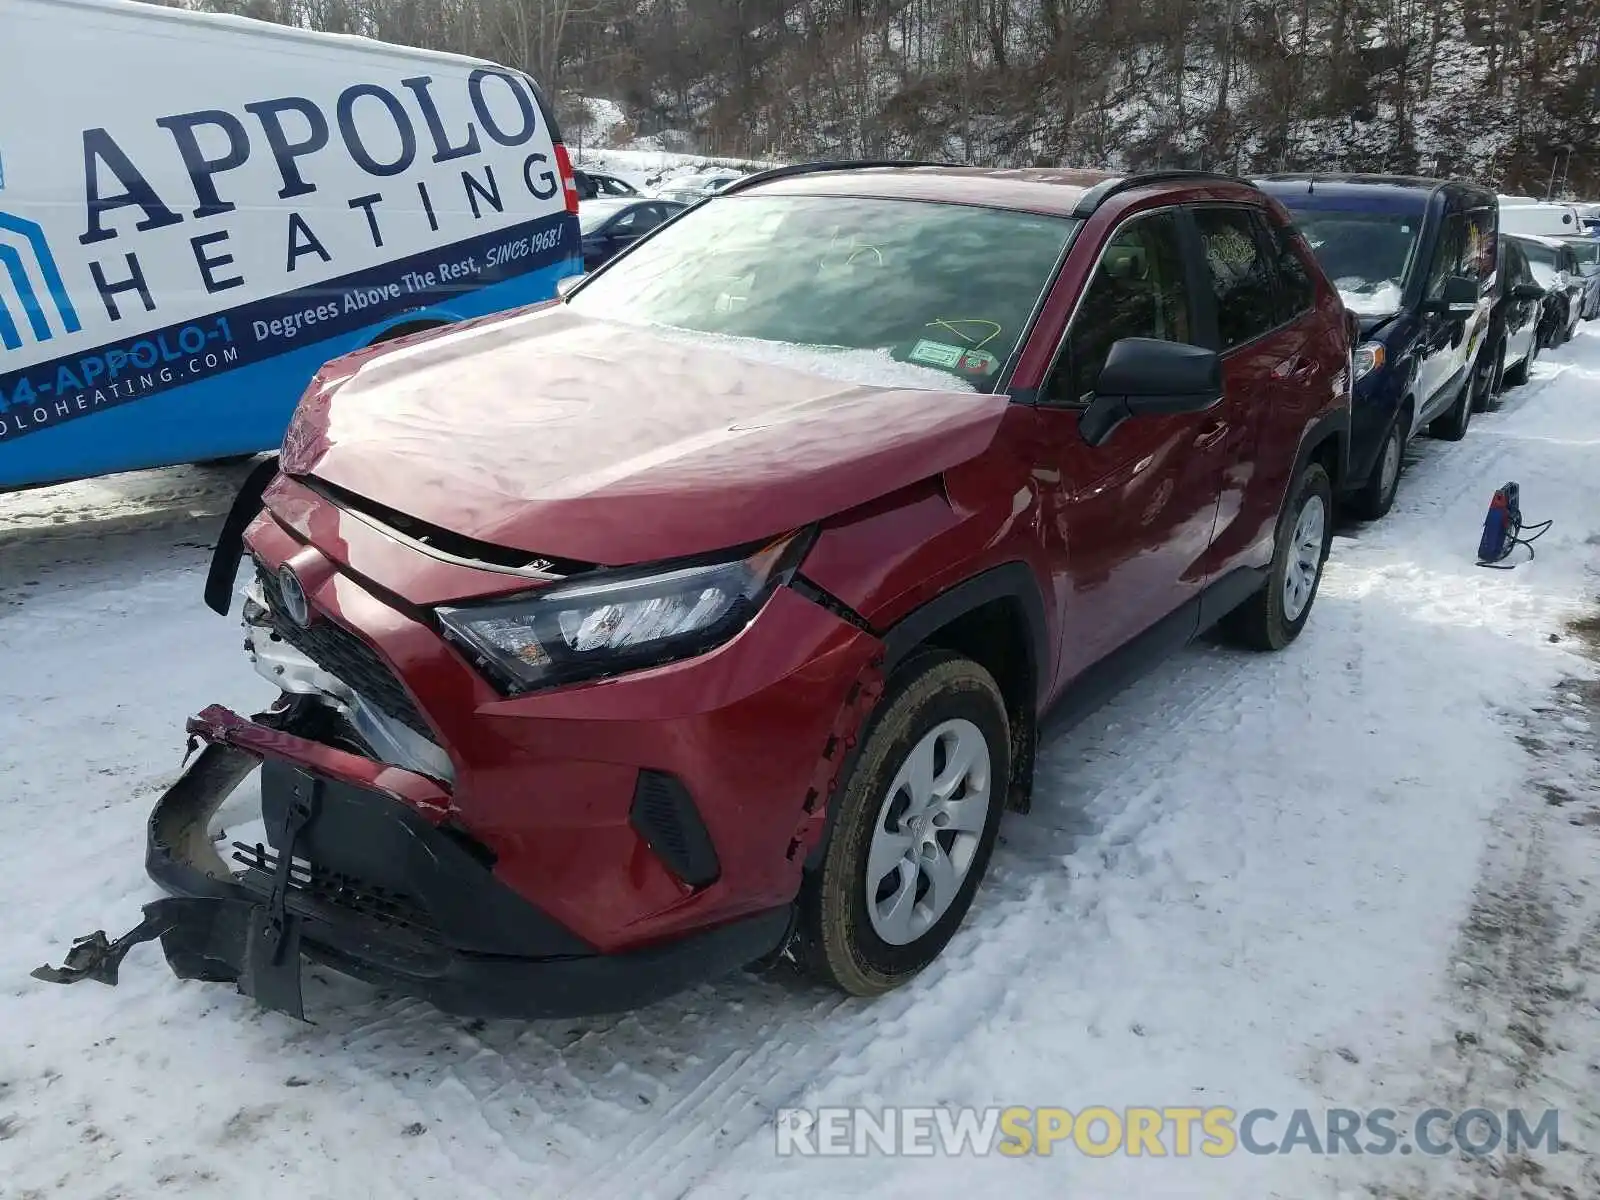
[798,651,1011,995]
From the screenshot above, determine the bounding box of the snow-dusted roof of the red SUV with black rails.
[723,163,1259,216]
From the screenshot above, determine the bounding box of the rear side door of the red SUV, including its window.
[1194,205,1333,582]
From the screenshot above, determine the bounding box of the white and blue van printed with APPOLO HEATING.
[0,0,582,490]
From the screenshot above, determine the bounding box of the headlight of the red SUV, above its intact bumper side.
[435,533,810,694]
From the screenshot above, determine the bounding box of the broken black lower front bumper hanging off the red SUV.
[34,701,792,1019]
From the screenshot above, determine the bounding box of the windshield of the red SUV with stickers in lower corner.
[570,195,1078,392]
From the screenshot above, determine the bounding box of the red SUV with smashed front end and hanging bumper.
[40,163,1350,1016]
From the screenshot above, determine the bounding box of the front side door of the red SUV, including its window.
[1035,210,1222,685]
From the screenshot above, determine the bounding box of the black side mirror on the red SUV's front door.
[1078,338,1222,446]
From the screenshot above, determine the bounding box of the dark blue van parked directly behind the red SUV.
[1259,174,1499,520]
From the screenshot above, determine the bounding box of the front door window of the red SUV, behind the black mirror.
[1045,213,1194,405]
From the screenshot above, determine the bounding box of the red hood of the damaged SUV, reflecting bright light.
[283,304,1008,565]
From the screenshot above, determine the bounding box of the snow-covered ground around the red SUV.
[0,333,1600,1200]
